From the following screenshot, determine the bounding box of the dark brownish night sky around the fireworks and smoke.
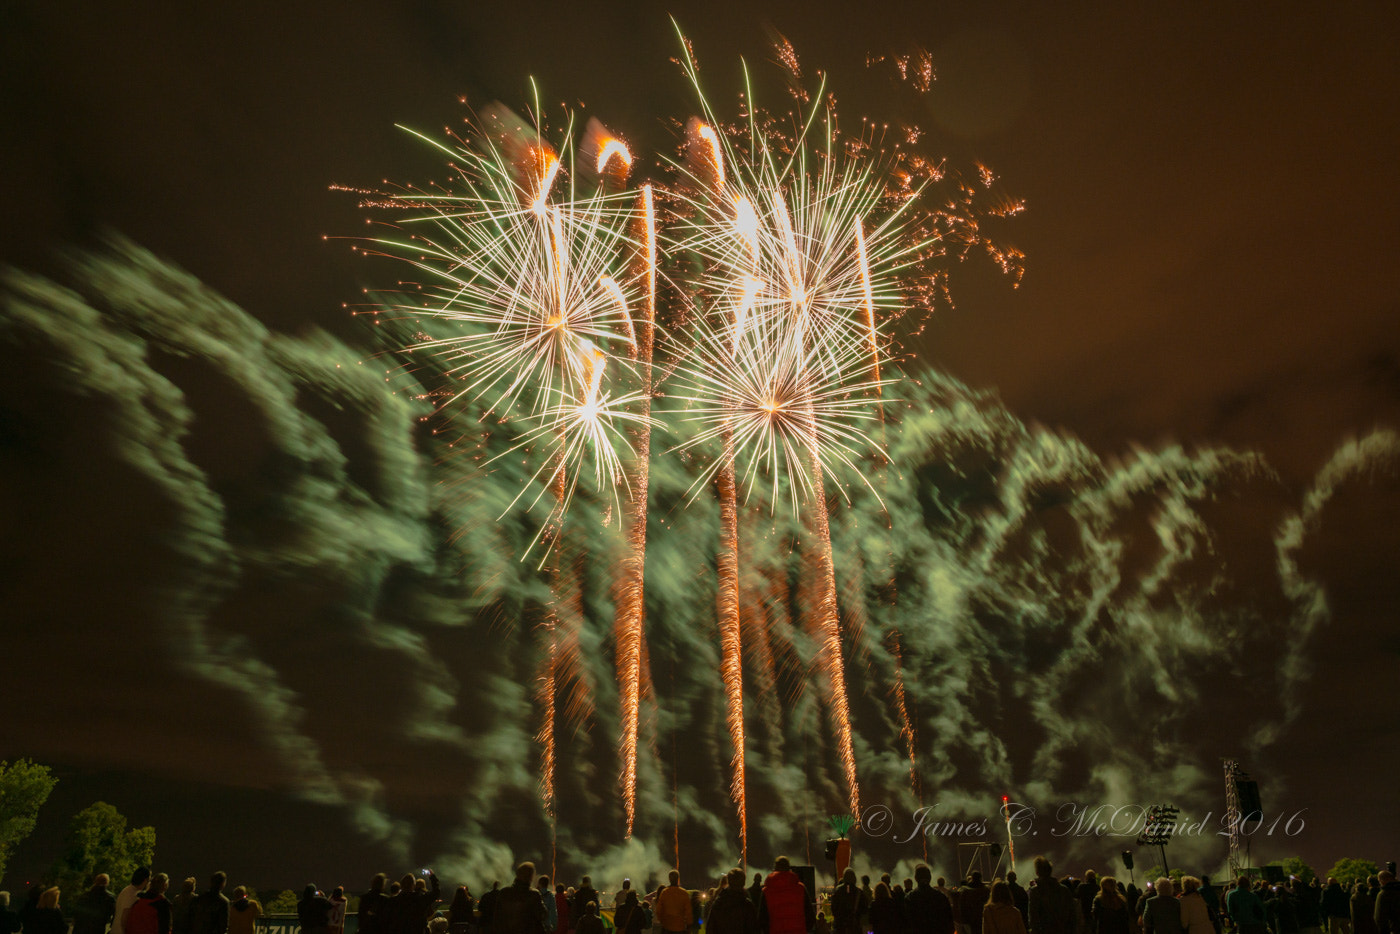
[0,0,1400,889]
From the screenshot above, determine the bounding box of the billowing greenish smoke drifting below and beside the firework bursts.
[0,241,1400,881]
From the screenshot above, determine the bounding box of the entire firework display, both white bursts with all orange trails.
[352,20,1022,861]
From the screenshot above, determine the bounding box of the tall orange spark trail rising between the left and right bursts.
[613,185,657,837]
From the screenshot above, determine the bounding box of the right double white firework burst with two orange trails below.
[660,29,925,828]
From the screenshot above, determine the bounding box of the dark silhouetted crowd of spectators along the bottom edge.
[0,857,1400,934]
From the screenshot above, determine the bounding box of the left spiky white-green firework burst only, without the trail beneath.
[367,96,641,467]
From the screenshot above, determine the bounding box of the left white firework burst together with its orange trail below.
[352,93,654,816]
